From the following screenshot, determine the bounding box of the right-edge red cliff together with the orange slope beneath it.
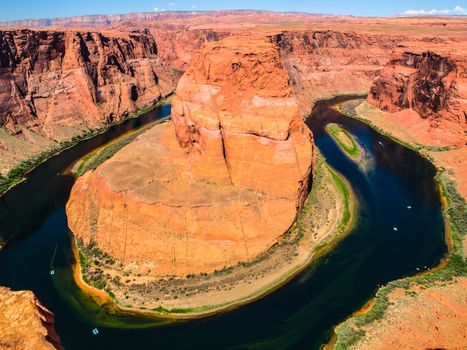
[366,46,467,198]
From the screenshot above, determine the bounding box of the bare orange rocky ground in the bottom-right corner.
[351,278,467,350]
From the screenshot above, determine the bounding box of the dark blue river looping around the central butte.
[0,97,446,349]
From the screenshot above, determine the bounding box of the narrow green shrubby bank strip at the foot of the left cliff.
[0,93,173,196]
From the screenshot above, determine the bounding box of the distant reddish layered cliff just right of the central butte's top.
[270,30,404,113]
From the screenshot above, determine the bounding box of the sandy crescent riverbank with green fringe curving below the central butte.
[75,152,357,318]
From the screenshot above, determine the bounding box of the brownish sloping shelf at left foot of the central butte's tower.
[97,122,258,207]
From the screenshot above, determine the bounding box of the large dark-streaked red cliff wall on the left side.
[0,29,178,175]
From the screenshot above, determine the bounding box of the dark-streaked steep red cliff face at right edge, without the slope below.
[368,51,467,127]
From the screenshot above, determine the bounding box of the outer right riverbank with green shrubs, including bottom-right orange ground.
[328,101,467,349]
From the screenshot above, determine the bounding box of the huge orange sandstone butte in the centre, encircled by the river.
[67,38,313,276]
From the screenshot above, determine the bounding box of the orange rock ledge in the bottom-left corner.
[0,287,63,350]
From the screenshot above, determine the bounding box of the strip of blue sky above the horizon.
[0,0,467,21]
